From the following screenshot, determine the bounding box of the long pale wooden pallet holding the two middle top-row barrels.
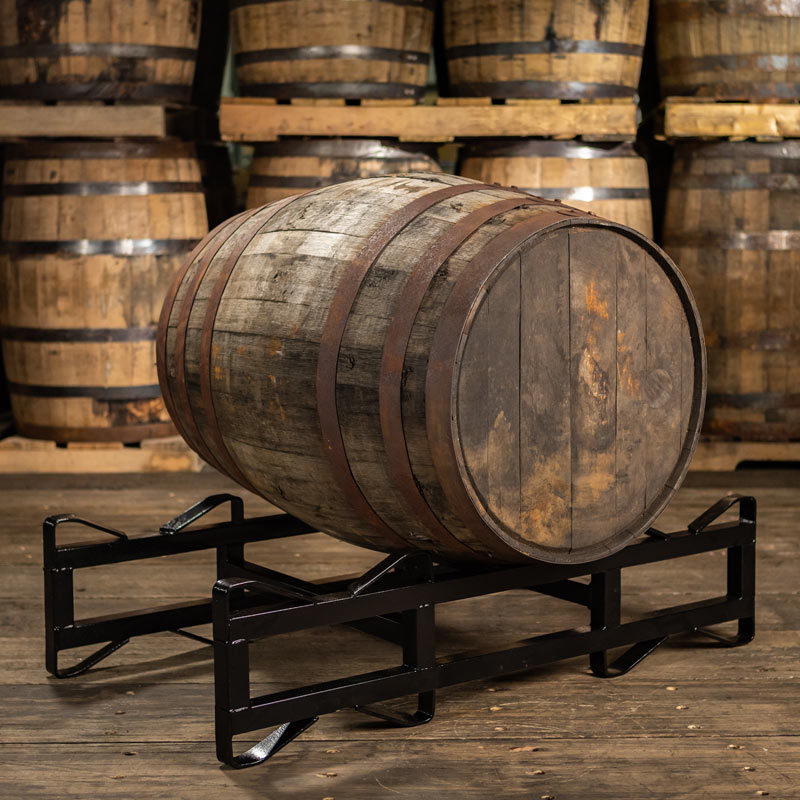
[220,97,637,142]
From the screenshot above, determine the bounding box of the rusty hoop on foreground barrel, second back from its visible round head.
[380,197,537,552]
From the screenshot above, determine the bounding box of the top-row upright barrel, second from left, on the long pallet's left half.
[231,0,435,98]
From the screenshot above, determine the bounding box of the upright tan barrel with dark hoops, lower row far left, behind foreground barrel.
[0,142,208,442]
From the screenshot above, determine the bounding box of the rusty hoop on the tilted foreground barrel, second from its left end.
[170,208,258,472]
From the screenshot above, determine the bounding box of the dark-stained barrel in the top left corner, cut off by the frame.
[0,0,200,102]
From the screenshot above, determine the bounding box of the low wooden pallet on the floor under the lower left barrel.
[0,436,203,474]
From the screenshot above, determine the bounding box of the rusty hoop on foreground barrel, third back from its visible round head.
[317,183,497,547]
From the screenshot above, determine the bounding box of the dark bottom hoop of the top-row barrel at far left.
[0,80,192,102]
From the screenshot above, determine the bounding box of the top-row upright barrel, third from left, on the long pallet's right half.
[444,0,648,99]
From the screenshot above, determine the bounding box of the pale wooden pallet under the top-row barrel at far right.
[659,97,800,142]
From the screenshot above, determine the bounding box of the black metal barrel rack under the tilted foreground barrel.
[44,494,756,768]
